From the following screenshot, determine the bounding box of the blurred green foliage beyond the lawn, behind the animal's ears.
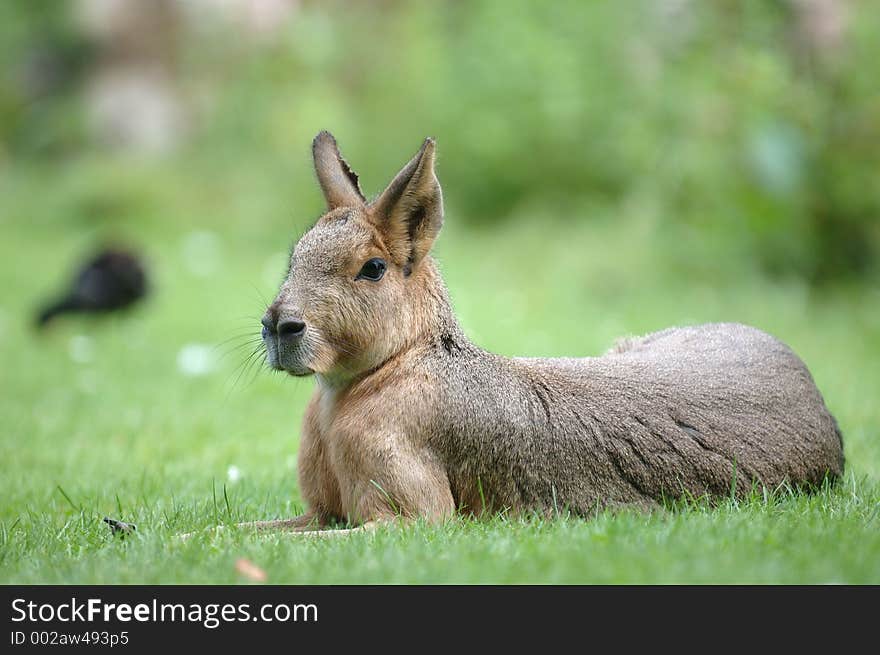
[0,0,880,283]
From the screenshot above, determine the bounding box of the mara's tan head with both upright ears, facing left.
[262,132,443,379]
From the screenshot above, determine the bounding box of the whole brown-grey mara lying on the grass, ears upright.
[253,132,843,529]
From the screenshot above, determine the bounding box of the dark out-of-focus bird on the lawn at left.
[37,250,147,327]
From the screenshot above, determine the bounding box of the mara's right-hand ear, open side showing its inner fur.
[369,138,443,275]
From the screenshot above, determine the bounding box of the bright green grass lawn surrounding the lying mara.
[0,158,880,584]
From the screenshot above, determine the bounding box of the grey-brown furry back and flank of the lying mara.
[439,324,843,513]
